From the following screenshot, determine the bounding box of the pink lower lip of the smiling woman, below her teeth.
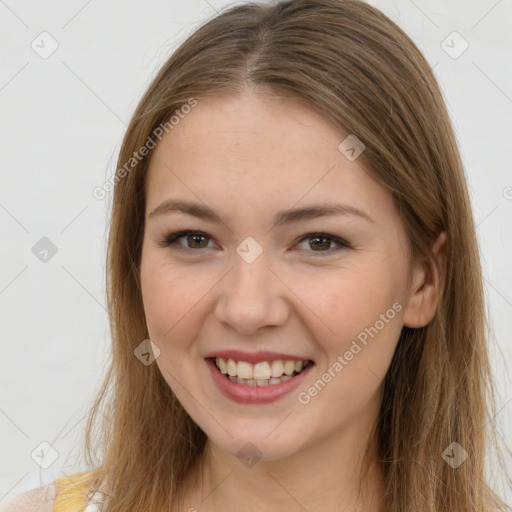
[206,359,314,404]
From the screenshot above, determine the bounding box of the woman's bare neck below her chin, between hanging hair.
[174,394,384,512]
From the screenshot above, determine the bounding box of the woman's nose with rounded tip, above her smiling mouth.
[215,252,290,334]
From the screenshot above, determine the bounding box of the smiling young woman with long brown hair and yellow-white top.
[6,0,510,512]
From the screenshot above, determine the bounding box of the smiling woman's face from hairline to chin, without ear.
[140,92,416,460]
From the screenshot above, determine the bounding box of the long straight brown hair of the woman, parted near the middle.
[69,0,510,512]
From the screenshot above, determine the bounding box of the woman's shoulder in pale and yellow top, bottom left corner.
[0,471,98,512]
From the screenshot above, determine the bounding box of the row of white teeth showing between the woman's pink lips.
[207,357,315,387]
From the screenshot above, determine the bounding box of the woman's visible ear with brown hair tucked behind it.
[403,231,448,328]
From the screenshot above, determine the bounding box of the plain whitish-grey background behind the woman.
[0,0,512,501]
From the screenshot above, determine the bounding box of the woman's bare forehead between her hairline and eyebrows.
[146,92,393,226]
